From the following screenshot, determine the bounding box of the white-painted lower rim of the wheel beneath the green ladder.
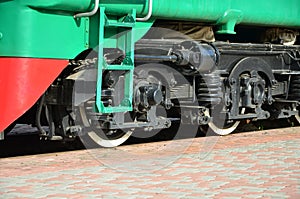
[79,106,133,148]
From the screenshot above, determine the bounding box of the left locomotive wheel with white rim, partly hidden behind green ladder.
[74,62,133,148]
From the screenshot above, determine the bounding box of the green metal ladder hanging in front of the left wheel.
[96,7,136,113]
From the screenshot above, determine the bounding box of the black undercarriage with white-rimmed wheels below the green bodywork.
[36,39,300,147]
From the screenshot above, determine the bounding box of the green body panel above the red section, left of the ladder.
[0,0,89,59]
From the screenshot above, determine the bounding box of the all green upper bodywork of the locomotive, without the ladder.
[0,0,300,59]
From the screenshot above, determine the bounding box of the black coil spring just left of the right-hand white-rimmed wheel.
[197,73,222,105]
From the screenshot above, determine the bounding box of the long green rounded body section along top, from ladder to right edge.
[100,0,300,33]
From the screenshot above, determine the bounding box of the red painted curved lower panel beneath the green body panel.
[0,58,68,132]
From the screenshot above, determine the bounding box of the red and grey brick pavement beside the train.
[0,128,300,199]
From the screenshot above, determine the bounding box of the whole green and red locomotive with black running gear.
[0,0,300,147]
